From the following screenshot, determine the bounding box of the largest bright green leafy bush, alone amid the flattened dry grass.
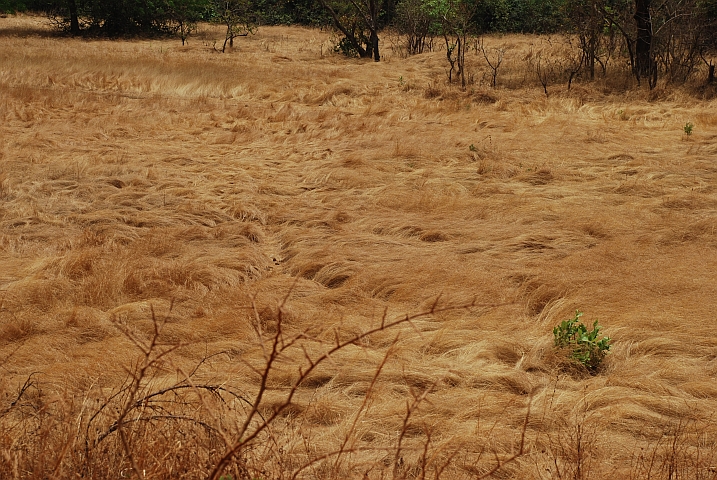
[553,310,610,373]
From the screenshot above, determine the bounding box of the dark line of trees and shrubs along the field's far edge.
[0,0,717,86]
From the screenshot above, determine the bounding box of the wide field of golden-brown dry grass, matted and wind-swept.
[0,13,717,479]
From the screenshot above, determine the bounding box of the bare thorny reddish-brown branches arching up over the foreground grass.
[60,286,529,480]
